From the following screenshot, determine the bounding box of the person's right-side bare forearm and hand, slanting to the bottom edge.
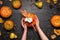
[36,16,49,40]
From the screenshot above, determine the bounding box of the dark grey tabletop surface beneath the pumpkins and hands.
[0,0,60,40]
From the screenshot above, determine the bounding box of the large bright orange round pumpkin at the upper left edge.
[1,6,12,18]
